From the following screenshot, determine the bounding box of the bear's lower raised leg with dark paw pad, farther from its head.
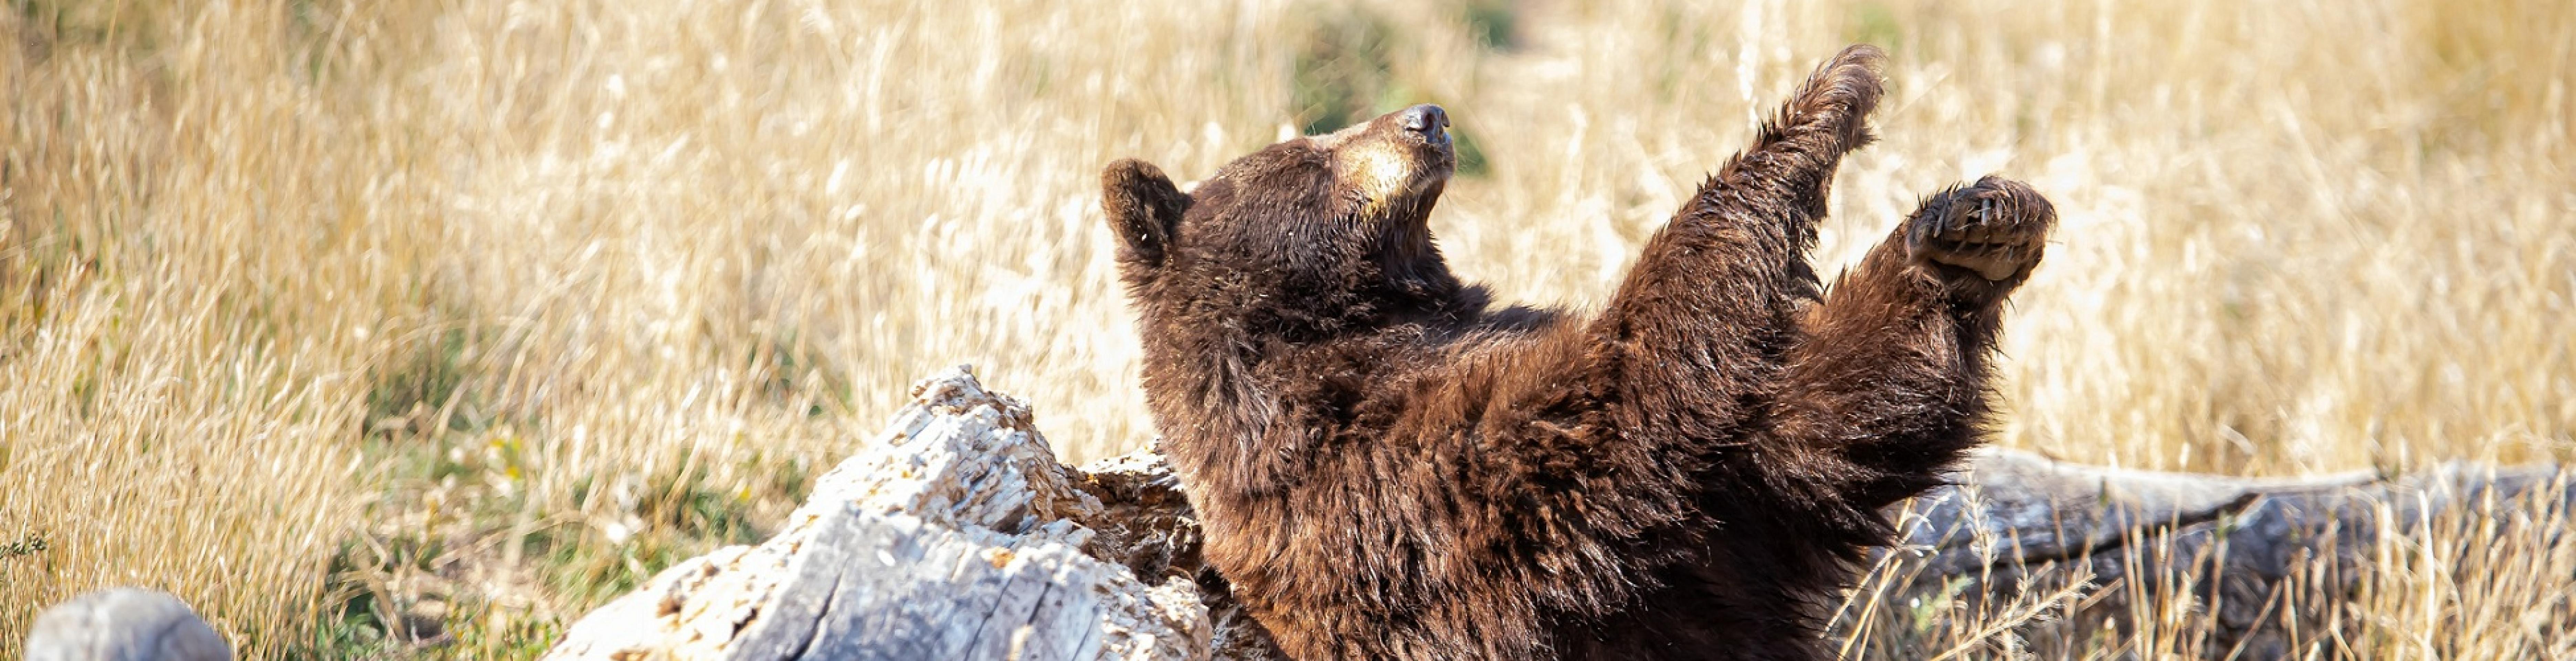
[1770,177,2056,514]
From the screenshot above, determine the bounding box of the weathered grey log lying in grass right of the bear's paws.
[1888,450,2576,659]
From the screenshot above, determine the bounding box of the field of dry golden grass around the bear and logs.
[0,0,2576,659]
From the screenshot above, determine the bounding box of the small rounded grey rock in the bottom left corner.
[26,586,232,661]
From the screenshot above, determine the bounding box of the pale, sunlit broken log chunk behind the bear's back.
[546,368,1211,661]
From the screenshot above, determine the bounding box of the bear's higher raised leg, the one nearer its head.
[1587,46,1883,437]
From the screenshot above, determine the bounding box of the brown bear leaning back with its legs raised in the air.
[1102,46,2056,661]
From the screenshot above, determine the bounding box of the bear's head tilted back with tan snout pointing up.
[1100,105,1458,339]
